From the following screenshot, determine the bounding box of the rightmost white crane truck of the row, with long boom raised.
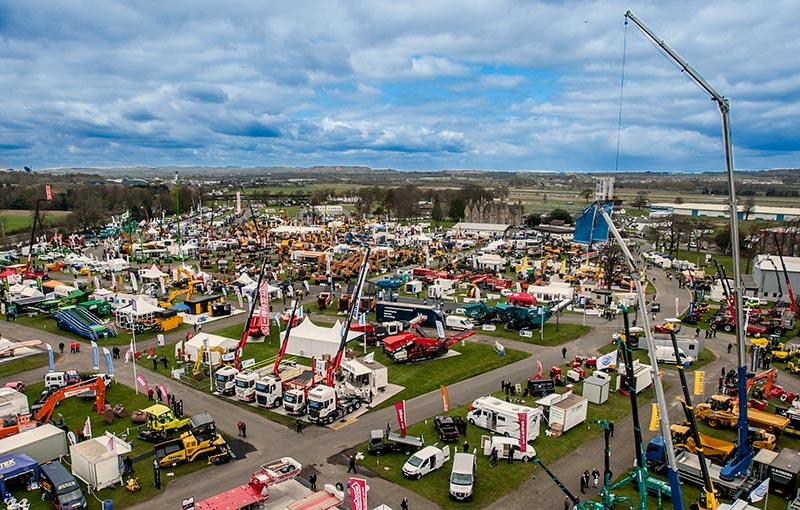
[308,247,370,424]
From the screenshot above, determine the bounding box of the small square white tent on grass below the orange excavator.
[69,432,131,491]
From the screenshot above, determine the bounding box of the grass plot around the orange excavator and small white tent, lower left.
[15,383,219,510]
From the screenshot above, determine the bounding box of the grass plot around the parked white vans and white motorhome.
[360,368,664,509]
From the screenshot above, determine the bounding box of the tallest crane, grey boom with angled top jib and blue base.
[624,11,752,484]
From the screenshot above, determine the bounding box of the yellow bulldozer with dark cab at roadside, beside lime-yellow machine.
[154,413,232,467]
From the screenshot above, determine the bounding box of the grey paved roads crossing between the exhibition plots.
[12,269,776,509]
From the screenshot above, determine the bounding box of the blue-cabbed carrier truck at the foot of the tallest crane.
[645,436,757,499]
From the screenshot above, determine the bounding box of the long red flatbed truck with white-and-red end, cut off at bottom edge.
[194,457,303,510]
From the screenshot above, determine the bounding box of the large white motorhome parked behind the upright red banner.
[467,396,544,441]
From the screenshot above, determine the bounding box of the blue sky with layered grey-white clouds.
[0,0,800,171]
